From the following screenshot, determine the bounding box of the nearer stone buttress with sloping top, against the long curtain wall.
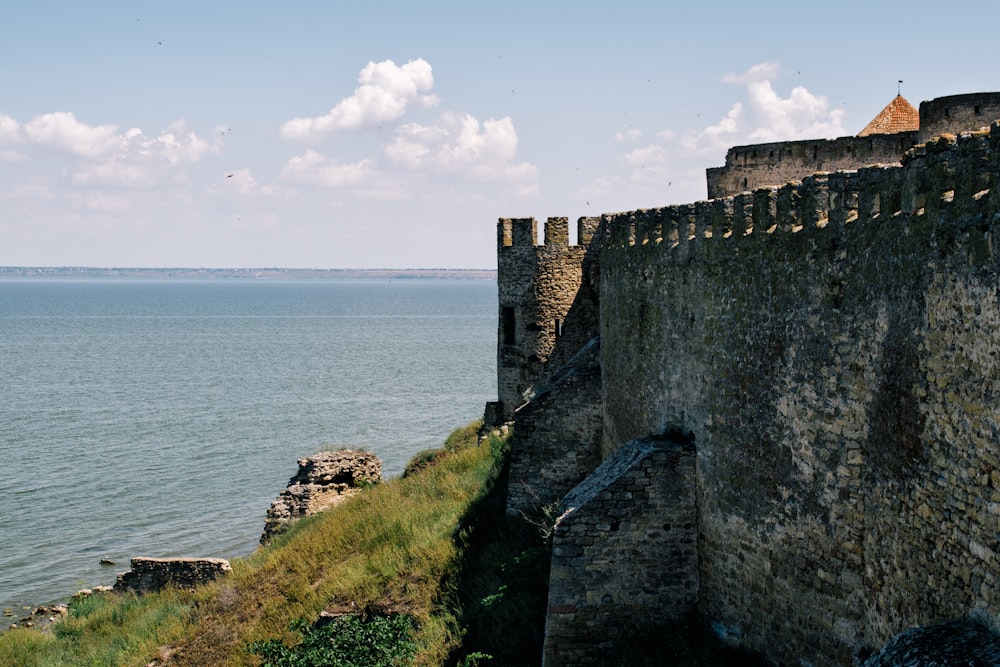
[543,438,698,667]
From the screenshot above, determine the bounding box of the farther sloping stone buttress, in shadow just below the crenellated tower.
[507,338,604,520]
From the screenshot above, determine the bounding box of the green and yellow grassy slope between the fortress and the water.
[0,424,547,666]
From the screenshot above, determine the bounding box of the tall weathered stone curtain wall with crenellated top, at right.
[600,125,1000,666]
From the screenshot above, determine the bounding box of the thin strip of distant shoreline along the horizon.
[0,266,497,280]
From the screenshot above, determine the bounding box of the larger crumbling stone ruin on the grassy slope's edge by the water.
[260,449,382,544]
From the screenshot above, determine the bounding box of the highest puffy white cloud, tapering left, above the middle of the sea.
[281,58,438,141]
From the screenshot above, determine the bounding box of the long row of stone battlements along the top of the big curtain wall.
[604,123,1000,257]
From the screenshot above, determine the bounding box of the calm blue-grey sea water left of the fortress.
[0,279,497,613]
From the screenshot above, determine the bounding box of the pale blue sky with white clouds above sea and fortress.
[0,0,1000,269]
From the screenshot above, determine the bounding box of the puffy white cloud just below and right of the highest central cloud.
[385,113,538,182]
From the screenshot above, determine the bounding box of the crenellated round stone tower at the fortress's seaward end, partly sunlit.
[497,218,597,421]
